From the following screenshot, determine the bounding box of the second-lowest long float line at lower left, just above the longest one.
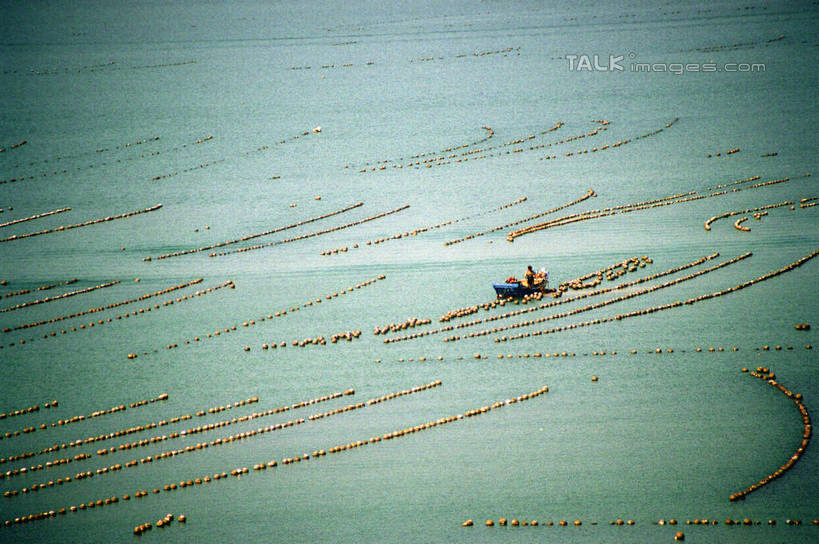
[4,380,441,498]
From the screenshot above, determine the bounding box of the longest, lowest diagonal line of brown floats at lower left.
[2,382,549,527]
